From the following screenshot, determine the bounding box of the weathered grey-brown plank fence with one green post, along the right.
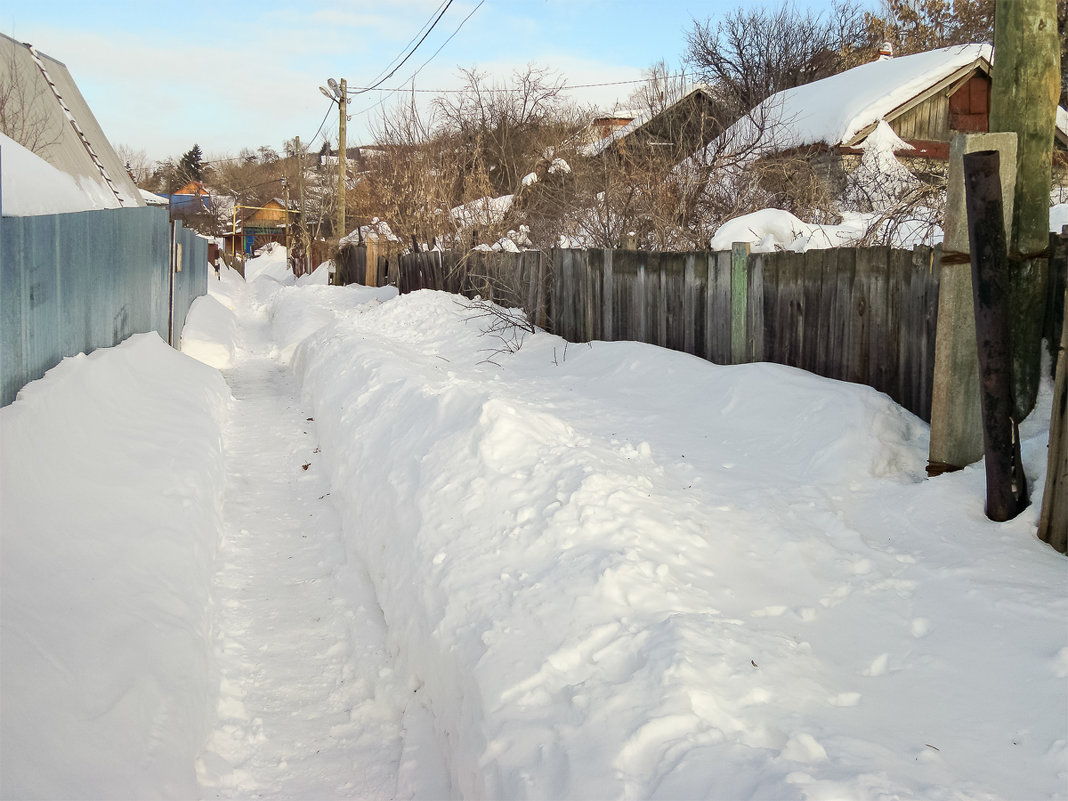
[387,236,1068,421]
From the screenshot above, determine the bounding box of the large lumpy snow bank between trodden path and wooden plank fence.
[274,290,1068,799]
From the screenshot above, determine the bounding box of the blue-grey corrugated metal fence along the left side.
[0,207,208,406]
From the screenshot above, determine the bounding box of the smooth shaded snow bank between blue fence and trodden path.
[0,333,230,798]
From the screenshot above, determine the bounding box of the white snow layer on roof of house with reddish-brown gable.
[726,45,992,151]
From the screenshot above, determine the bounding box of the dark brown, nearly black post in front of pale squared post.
[963,151,1027,522]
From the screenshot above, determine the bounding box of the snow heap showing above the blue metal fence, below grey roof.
[0,134,119,217]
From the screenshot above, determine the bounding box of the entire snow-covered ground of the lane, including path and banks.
[0,247,1068,799]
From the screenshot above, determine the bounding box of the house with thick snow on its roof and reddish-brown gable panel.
[712,44,1068,191]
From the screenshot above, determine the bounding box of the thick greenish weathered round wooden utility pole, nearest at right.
[990,0,1061,422]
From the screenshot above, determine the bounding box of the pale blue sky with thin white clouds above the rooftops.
[0,0,829,160]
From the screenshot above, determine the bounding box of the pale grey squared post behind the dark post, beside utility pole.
[927,128,1016,476]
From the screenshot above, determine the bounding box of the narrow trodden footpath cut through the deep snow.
[198,279,440,799]
